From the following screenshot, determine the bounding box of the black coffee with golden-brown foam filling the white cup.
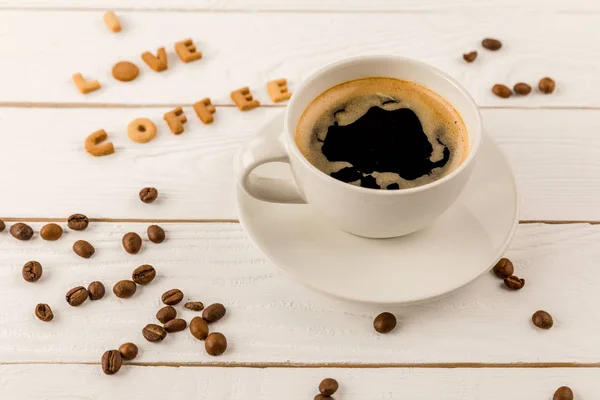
[295,78,469,189]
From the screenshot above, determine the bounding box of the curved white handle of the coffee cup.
[237,135,306,204]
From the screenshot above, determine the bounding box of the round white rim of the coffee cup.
[285,55,483,196]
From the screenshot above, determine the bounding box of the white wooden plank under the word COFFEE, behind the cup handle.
[0,107,600,221]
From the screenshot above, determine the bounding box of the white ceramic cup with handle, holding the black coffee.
[236,56,483,238]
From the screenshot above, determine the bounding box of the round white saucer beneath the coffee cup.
[236,113,519,305]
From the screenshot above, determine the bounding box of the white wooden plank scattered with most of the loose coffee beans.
[0,223,600,366]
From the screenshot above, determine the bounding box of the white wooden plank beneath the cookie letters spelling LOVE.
[0,10,600,107]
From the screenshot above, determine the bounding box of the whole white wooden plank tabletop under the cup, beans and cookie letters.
[0,0,600,400]
